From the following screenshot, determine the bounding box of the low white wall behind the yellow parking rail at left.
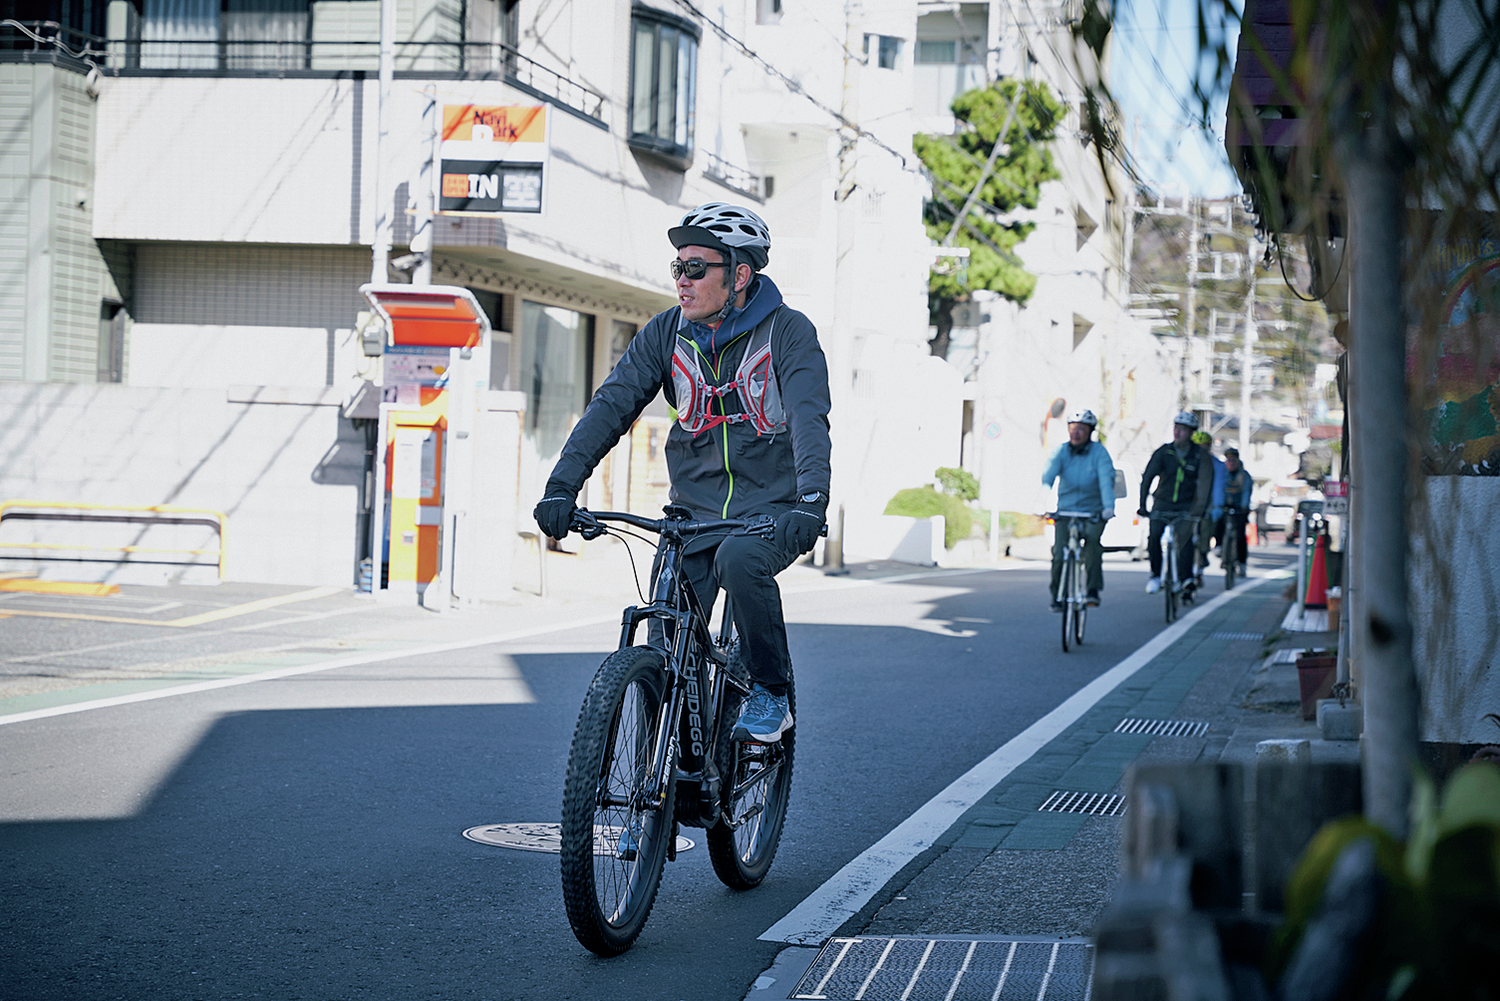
[0,383,363,585]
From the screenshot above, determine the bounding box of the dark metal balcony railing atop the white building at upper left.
[0,20,608,128]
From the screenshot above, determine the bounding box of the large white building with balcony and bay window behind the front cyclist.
[0,0,942,596]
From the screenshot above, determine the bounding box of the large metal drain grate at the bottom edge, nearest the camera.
[791,936,1094,1001]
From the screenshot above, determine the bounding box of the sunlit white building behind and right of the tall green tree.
[915,0,1178,512]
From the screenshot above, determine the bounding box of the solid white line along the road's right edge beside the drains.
[761,578,1272,945]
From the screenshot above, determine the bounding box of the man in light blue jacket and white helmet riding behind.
[1041,410,1115,612]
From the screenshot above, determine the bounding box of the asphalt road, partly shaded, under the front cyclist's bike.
[0,561,1194,1001]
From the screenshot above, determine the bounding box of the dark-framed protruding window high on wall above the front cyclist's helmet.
[627,6,699,170]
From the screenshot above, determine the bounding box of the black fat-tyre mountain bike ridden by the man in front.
[563,507,797,956]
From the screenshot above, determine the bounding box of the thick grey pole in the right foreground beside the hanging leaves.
[1344,131,1418,837]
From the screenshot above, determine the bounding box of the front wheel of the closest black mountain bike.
[563,647,677,956]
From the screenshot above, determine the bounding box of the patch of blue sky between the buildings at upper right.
[1110,0,1239,198]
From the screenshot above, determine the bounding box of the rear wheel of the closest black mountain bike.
[704,666,797,890]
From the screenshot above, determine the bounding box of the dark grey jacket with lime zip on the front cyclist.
[546,275,831,518]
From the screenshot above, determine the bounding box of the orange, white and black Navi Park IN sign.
[437,104,549,216]
